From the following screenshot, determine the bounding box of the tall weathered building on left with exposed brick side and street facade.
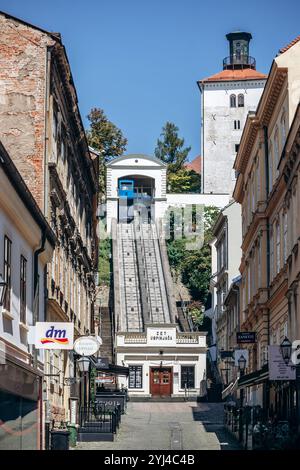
[0,13,97,422]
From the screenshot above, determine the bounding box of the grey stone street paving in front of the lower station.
[76,402,239,450]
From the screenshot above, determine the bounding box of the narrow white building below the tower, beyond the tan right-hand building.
[206,201,242,388]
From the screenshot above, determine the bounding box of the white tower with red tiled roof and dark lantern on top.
[198,31,267,195]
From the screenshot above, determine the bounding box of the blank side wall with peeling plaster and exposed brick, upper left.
[0,14,55,210]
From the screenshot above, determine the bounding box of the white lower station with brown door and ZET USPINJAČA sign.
[116,325,206,399]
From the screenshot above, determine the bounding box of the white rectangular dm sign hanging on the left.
[34,322,74,349]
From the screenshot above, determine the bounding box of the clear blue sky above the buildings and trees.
[0,0,300,159]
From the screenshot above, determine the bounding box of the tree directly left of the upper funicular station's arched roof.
[86,108,127,194]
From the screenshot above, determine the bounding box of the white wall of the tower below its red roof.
[202,80,265,194]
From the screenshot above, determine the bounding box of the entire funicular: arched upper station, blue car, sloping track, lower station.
[106,155,228,399]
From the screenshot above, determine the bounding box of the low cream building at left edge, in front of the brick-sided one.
[0,144,56,450]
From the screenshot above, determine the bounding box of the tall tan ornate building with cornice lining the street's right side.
[234,35,300,419]
